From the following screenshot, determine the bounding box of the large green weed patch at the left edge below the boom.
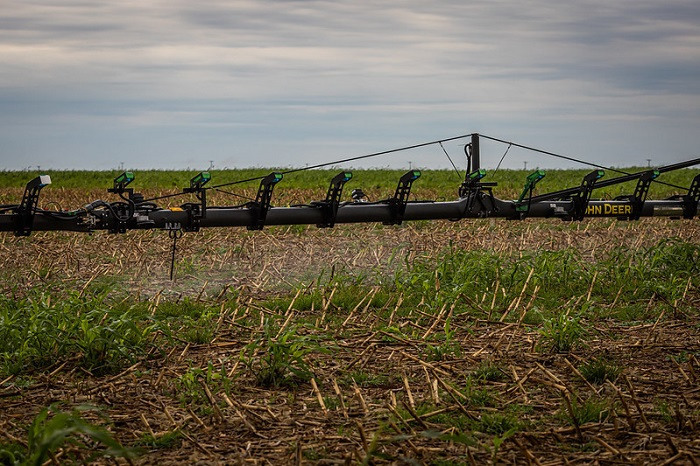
[0,292,155,374]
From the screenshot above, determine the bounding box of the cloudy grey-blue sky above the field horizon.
[0,0,700,170]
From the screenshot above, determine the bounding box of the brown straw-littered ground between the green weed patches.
[0,219,700,465]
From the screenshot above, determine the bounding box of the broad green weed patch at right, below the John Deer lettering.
[394,239,700,326]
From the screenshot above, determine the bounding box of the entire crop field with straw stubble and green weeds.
[0,170,700,465]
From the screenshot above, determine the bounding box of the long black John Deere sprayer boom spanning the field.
[0,134,700,236]
